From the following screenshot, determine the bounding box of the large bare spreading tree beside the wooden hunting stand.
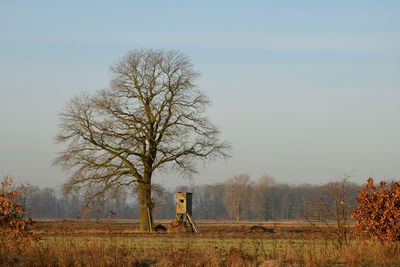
[55,50,230,231]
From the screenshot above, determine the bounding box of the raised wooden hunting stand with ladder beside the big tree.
[176,192,199,233]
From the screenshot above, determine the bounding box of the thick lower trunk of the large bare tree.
[139,183,153,232]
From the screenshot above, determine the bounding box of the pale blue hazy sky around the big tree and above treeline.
[0,0,400,191]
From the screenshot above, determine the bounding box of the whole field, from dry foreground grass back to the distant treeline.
[0,220,400,266]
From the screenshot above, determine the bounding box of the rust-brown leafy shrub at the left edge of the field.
[0,177,34,242]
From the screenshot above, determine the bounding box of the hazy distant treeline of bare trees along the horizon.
[14,175,362,221]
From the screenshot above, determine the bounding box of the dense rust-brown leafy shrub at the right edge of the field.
[351,178,400,242]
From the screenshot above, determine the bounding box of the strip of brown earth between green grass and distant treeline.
[34,220,326,239]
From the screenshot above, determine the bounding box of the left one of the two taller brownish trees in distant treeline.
[224,174,250,221]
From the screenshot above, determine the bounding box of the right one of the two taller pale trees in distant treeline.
[250,175,276,220]
